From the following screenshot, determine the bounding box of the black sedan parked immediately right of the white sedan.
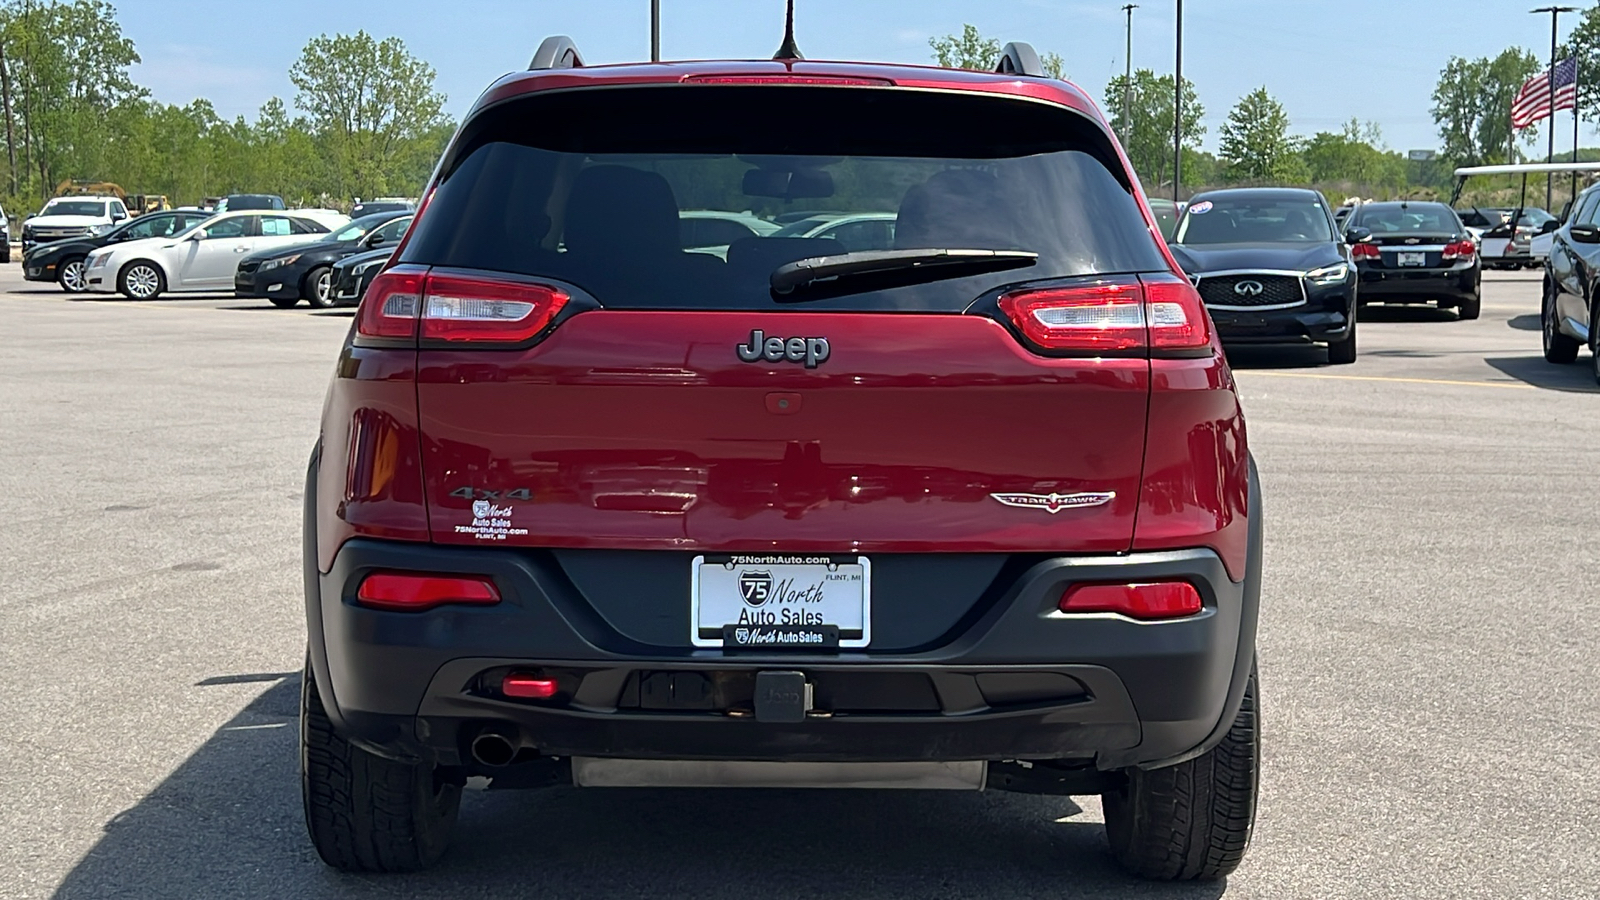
[234,211,411,309]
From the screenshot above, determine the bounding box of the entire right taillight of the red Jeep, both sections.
[998,275,1211,352]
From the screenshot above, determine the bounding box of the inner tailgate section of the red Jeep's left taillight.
[422,274,570,343]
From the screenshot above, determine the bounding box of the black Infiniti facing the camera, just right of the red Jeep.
[1173,187,1357,364]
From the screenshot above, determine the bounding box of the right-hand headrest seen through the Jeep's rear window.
[894,168,1016,248]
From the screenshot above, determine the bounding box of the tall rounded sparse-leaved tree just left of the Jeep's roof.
[290,30,448,197]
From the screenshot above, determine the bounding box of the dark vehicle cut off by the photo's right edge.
[1539,184,1600,384]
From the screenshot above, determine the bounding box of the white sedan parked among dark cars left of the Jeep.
[86,210,330,299]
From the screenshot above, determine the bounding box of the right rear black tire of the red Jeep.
[1101,663,1261,881]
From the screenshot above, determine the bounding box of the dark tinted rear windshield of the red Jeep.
[403,86,1166,312]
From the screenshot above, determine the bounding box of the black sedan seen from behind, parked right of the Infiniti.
[1346,200,1483,319]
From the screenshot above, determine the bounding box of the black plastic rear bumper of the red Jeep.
[306,454,1259,769]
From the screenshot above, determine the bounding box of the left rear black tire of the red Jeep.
[301,650,461,873]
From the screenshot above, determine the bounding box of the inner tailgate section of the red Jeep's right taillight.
[1000,282,1147,351]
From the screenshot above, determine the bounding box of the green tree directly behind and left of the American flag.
[1429,46,1541,165]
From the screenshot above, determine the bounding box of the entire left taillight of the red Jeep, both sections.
[355,266,570,344]
